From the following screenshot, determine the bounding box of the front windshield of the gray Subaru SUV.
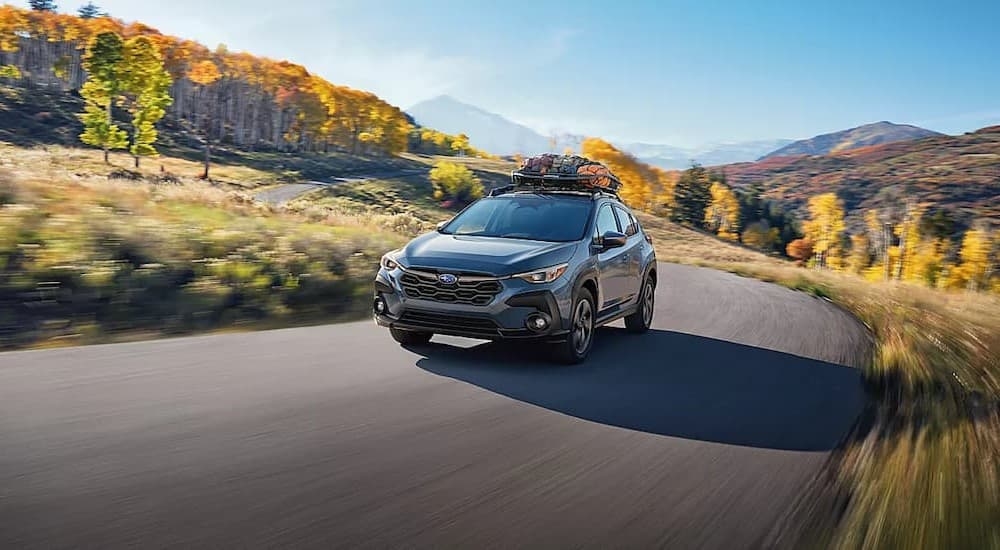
[441,195,593,242]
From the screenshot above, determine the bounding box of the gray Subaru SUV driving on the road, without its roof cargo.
[373,178,656,363]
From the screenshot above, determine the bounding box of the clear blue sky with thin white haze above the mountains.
[15,0,1000,146]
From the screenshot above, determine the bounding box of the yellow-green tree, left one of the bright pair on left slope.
[80,32,128,163]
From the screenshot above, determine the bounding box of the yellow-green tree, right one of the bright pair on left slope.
[121,36,172,168]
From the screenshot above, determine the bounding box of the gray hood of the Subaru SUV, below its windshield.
[398,232,577,277]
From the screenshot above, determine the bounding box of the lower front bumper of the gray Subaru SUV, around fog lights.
[373,269,572,341]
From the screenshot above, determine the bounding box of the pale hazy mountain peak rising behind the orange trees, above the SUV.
[407,95,550,155]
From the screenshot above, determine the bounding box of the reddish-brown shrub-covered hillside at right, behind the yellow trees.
[720,126,1000,223]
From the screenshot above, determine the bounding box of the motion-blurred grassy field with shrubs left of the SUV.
[0,146,405,348]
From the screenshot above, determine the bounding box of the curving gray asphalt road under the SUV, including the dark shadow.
[0,265,866,549]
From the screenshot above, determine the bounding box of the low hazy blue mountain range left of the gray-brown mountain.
[620,139,792,170]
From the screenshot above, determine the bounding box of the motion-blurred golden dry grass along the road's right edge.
[643,222,1000,549]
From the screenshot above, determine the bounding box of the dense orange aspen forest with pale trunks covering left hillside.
[0,5,470,162]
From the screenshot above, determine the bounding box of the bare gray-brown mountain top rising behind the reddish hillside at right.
[763,120,944,158]
